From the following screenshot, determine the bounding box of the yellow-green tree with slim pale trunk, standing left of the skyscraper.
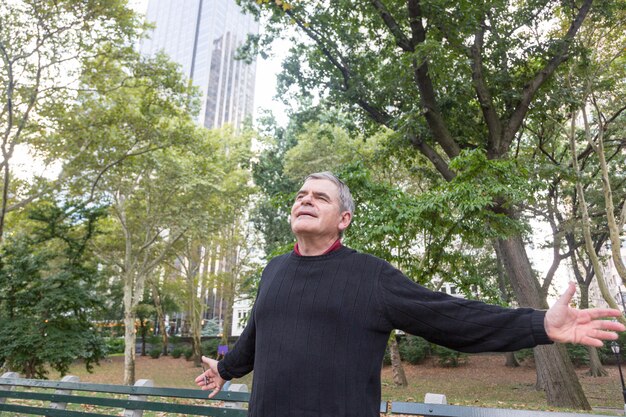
[52,51,208,384]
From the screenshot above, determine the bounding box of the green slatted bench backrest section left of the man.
[0,373,250,417]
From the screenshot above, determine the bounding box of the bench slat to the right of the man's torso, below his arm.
[391,402,600,417]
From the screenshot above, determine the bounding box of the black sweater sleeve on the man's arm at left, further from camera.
[217,307,256,381]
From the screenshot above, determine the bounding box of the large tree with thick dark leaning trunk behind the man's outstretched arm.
[243,0,618,409]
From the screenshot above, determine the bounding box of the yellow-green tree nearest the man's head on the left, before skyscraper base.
[176,127,253,366]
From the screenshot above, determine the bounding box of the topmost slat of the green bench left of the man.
[0,378,250,402]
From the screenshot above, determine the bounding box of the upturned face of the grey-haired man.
[290,179,351,238]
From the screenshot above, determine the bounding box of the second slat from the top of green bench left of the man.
[4,391,247,417]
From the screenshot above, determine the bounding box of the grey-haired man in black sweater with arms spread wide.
[196,172,624,417]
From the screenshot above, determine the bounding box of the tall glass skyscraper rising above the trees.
[140,0,259,128]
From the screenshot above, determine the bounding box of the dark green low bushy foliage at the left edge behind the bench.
[0,201,106,378]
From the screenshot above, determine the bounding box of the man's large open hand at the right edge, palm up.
[544,282,626,347]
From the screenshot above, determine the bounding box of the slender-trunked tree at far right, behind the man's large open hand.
[518,13,626,375]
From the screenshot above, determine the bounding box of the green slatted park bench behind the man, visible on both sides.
[0,372,612,417]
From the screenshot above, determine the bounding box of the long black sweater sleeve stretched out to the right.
[372,264,552,352]
